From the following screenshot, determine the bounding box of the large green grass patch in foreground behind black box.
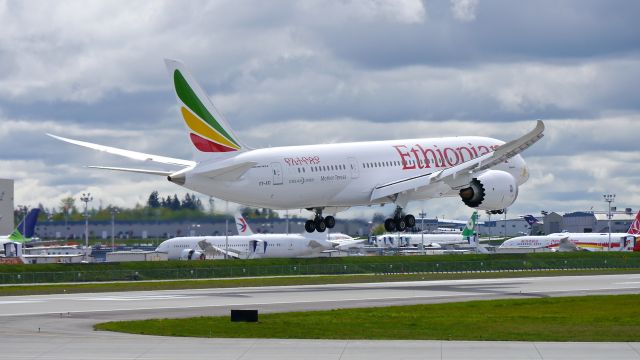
[95,295,640,341]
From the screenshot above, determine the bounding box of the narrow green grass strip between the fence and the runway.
[0,269,640,296]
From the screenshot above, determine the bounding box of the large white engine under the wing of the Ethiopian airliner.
[460,170,518,210]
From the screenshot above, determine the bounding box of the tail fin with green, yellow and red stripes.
[165,59,249,157]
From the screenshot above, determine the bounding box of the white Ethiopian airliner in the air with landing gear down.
[49,60,544,232]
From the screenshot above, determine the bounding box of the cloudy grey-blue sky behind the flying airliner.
[0,0,640,221]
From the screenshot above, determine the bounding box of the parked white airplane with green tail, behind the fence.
[373,211,478,248]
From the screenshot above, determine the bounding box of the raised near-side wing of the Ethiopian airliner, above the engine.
[371,120,544,201]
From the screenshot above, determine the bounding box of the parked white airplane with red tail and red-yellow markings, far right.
[498,212,640,251]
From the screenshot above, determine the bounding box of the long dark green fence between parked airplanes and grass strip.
[0,257,640,284]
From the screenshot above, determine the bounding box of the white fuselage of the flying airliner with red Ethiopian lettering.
[181,136,528,209]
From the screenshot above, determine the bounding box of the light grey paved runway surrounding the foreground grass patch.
[0,274,640,360]
